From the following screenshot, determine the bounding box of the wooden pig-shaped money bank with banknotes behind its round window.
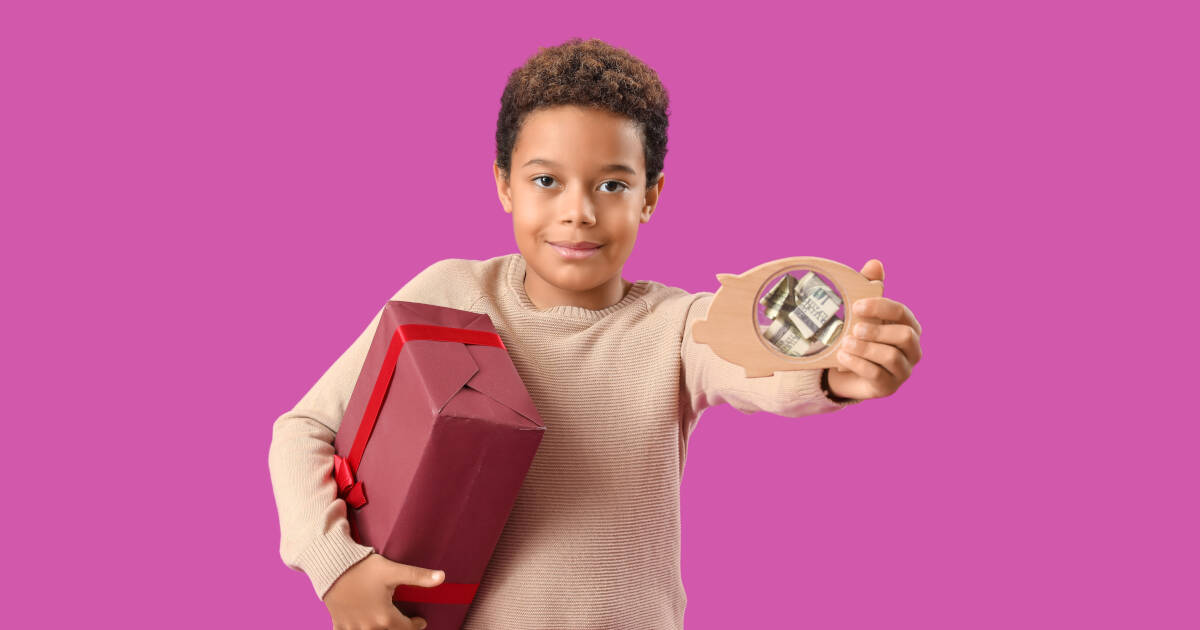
[691,256,883,377]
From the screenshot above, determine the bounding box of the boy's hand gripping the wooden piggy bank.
[828,258,920,400]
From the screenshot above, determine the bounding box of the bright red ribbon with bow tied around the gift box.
[334,324,508,604]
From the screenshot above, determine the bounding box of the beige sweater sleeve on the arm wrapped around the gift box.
[268,262,466,598]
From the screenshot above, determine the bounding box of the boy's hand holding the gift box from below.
[322,553,445,630]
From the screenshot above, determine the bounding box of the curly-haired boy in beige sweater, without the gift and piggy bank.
[270,38,919,630]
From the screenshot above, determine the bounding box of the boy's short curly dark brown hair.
[496,37,670,186]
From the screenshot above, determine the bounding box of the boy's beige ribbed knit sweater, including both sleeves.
[269,253,846,630]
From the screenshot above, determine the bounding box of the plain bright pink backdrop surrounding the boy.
[0,0,1200,630]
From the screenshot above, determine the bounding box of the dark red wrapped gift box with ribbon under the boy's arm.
[334,300,546,630]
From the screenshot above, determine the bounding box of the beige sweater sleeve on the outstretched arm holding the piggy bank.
[679,292,850,433]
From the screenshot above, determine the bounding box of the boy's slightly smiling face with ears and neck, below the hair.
[492,106,664,307]
